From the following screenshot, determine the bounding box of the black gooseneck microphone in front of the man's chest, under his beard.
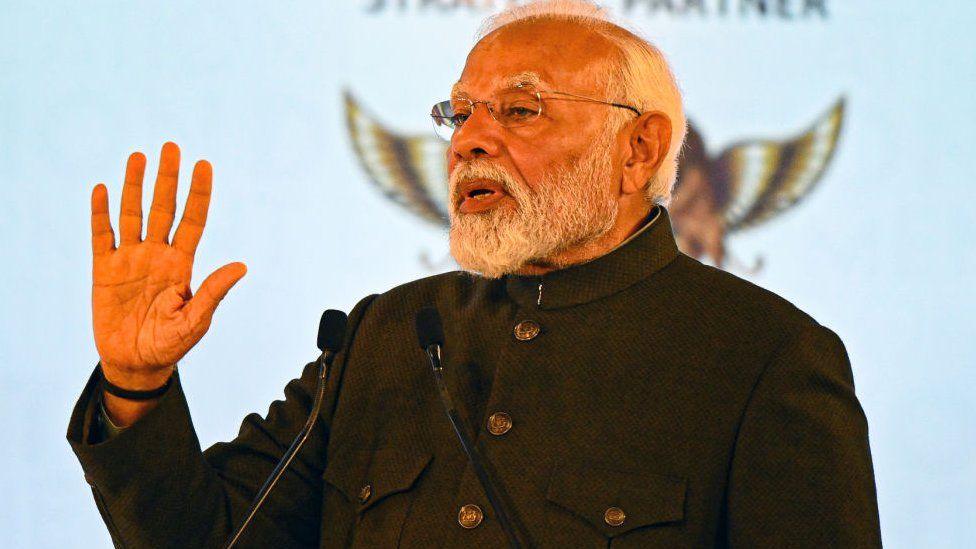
[415,307,521,549]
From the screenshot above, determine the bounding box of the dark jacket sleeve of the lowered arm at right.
[726,325,881,548]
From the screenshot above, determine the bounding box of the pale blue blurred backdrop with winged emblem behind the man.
[0,0,976,547]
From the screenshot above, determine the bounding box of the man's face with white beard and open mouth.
[448,21,620,277]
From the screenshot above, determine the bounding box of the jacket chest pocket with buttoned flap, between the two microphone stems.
[322,447,432,547]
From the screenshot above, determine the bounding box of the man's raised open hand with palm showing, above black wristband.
[91,143,247,396]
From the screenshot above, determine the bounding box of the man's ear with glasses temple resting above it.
[621,111,671,194]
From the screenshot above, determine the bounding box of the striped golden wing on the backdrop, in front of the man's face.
[343,91,449,227]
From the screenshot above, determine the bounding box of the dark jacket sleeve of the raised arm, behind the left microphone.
[67,296,375,548]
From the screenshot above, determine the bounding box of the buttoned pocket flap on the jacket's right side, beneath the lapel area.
[546,465,686,538]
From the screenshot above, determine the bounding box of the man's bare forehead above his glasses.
[452,20,615,96]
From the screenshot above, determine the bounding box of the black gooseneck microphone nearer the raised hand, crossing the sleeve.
[224,309,346,549]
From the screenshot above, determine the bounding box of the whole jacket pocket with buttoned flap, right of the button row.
[546,464,687,547]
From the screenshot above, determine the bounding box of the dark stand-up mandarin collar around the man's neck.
[505,205,678,309]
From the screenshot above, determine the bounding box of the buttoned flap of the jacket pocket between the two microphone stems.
[322,448,432,512]
